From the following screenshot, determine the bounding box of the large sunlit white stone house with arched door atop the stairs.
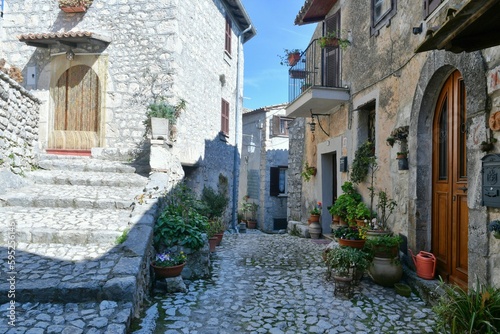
[0,0,256,219]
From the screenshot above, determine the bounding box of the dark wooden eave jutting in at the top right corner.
[415,0,500,53]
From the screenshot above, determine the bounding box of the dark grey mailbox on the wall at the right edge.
[481,154,500,208]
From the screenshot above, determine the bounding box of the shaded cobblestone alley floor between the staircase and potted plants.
[133,230,435,334]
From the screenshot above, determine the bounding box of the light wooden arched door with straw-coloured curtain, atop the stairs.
[49,65,100,150]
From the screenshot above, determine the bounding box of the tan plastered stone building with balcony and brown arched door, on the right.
[287,0,500,286]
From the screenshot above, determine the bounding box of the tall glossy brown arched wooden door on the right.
[432,71,469,288]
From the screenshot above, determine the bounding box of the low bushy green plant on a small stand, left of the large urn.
[324,247,370,277]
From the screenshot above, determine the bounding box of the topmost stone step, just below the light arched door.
[38,155,136,173]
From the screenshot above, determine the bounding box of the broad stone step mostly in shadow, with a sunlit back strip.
[0,243,139,304]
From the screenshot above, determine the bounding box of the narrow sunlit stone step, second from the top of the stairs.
[26,169,148,187]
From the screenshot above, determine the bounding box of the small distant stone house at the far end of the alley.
[239,104,292,232]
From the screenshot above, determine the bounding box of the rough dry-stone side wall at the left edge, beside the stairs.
[0,71,40,174]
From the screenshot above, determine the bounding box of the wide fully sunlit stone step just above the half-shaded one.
[0,207,130,245]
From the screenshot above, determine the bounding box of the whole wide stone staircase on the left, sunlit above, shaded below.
[0,156,155,333]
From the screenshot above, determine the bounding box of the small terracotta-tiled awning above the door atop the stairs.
[17,31,111,48]
